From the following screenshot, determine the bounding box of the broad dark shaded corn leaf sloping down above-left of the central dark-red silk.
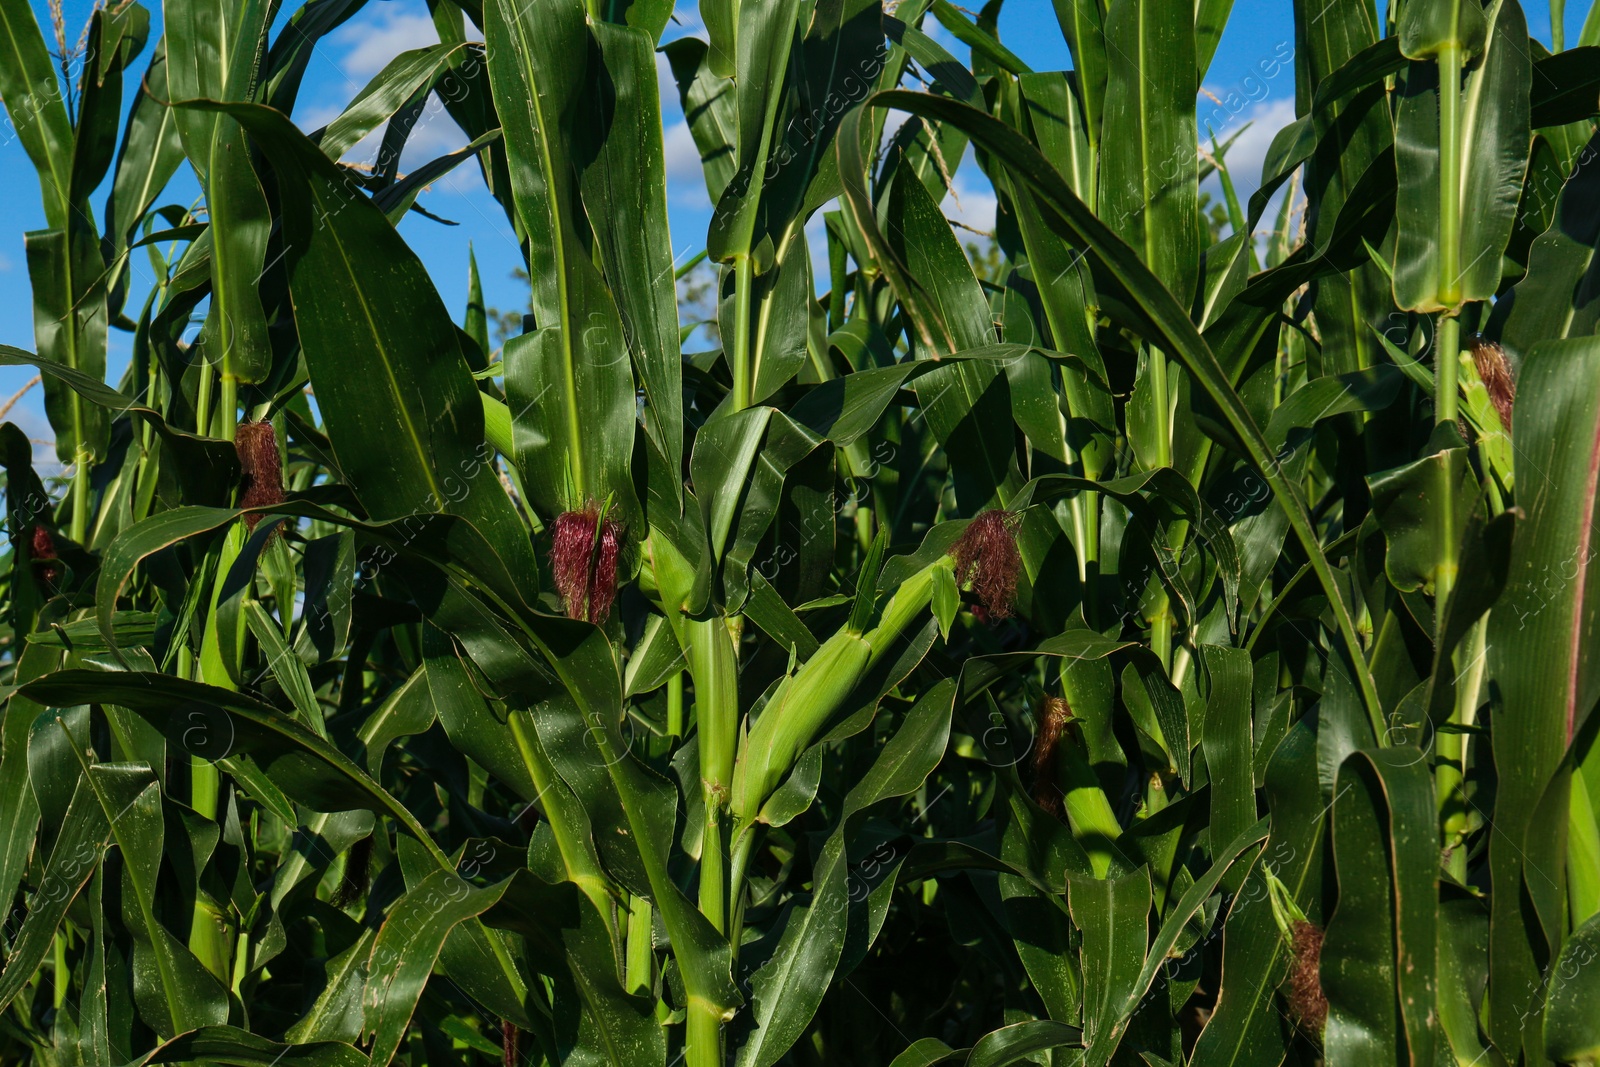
[190,104,538,582]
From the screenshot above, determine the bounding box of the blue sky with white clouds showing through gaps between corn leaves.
[0,0,1587,461]
